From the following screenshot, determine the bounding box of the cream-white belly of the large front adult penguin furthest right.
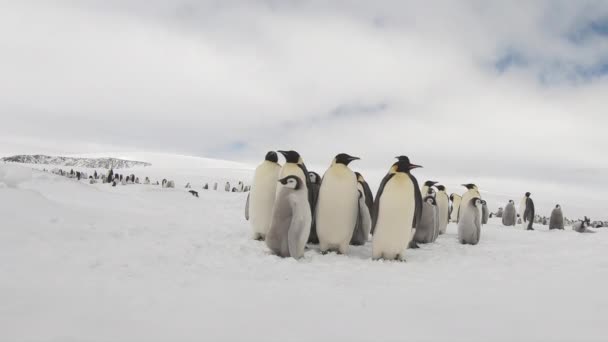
[372,173,416,260]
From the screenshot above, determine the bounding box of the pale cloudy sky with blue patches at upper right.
[0,0,608,215]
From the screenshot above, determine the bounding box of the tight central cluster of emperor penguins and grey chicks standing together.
[245,150,489,261]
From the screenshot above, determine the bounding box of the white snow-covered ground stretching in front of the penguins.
[0,162,608,341]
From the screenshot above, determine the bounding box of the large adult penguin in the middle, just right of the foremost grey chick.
[315,153,359,254]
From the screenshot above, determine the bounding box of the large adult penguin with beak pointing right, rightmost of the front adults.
[372,156,422,261]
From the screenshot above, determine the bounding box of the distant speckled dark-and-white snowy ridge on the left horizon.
[1,154,151,169]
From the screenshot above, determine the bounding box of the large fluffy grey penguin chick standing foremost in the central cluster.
[266,175,312,259]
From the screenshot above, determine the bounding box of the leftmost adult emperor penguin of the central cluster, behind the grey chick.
[245,151,281,240]
